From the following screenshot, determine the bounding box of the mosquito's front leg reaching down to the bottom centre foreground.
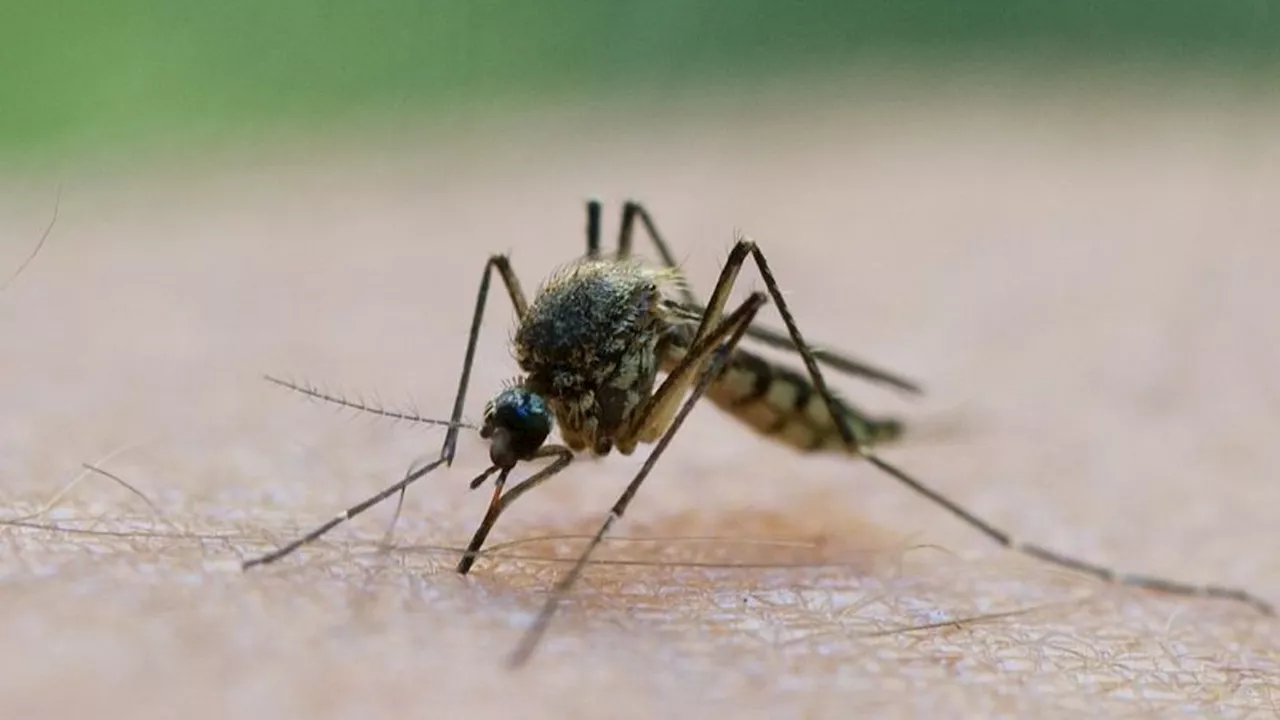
[508,288,765,667]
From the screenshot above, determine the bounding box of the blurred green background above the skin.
[0,0,1280,161]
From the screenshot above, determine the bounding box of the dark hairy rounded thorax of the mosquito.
[513,260,673,455]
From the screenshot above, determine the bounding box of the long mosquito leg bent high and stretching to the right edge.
[726,238,1275,615]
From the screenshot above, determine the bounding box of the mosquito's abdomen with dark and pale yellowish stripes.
[662,330,902,452]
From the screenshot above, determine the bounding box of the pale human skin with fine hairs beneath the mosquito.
[0,87,1280,719]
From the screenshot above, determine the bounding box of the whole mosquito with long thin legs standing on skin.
[244,201,1274,666]
